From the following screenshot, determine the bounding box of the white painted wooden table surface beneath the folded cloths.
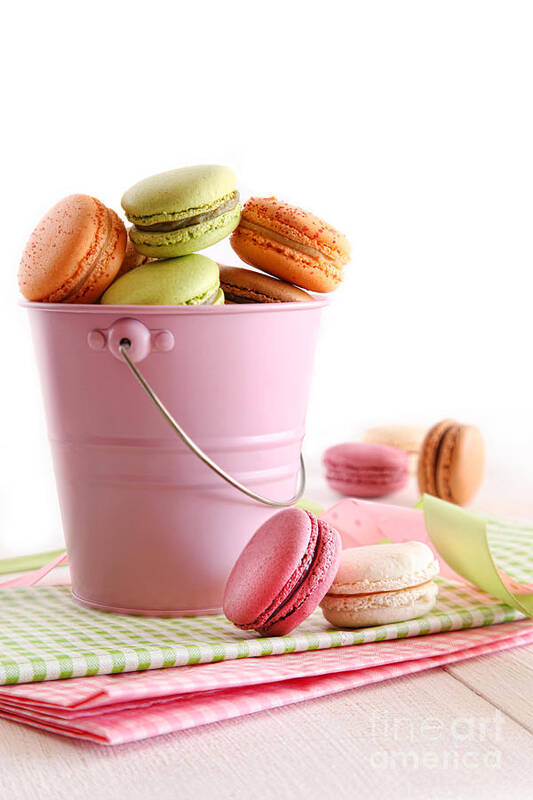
[0,476,533,800]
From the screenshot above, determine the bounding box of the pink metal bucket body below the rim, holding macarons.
[24,301,325,616]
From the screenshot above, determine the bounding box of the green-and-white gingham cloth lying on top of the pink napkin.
[0,581,522,684]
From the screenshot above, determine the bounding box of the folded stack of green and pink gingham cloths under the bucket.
[0,510,533,744]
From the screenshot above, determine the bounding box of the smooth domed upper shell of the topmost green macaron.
[121,164,237,223]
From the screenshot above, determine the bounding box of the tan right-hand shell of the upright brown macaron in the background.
[436,425,485,506]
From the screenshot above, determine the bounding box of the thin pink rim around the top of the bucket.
[19,297,331,316]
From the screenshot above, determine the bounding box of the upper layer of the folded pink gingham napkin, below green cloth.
[0,620,533,713]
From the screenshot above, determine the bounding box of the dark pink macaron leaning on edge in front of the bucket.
[223,508,341,636]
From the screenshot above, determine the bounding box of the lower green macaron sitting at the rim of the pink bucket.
[101,253,224,306]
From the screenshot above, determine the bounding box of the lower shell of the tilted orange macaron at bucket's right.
[230,227,342,292]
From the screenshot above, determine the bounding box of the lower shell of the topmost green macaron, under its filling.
[130,203,241,258]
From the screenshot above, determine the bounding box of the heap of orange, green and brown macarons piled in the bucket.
[19,165,350,306]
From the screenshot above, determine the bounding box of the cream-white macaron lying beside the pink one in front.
[320,542,439,628]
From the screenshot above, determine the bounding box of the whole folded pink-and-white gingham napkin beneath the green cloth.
[0,620,533,744]
